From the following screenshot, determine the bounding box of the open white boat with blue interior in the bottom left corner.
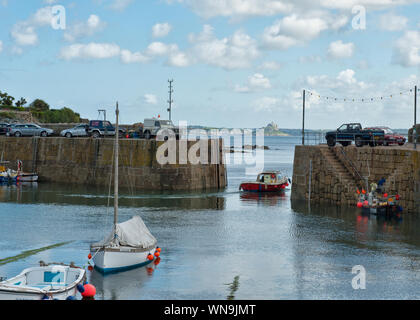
[0,265,86,300]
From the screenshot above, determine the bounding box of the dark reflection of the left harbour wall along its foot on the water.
[0,183,226,210]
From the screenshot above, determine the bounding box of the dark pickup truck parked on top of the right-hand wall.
[325,123,385,147]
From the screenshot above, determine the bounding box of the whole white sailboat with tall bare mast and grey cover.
[90,103,160,274]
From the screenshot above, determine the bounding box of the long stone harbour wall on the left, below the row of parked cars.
[0,137,227,191]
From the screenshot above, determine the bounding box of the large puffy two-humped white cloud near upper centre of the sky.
[190,25,259,70]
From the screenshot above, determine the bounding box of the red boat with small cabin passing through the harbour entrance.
[239,171,290,192]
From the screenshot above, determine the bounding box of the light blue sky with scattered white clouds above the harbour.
[0,0,420,129]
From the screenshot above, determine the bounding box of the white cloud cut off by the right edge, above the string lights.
[393,31,420,67]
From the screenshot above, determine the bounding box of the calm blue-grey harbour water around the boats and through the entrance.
[0,137,420,300]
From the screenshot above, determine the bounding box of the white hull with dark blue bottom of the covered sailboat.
[91,248,156,274]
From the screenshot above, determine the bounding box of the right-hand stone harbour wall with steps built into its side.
[292,145,420,213]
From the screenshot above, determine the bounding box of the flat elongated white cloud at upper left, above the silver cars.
[60,43,121,60]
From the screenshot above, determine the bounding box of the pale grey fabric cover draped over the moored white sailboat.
[92,216,157,249]
